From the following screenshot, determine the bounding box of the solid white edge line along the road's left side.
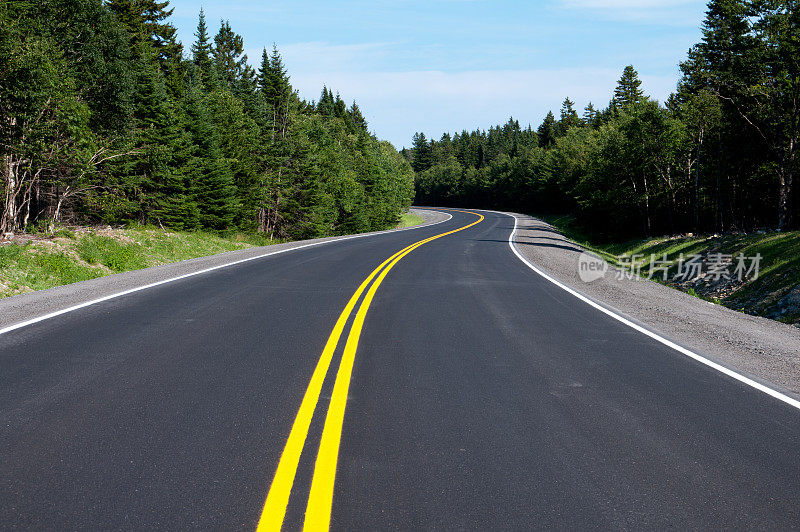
[0,209,453,335]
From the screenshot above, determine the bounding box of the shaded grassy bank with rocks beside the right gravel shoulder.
[539,216,800,324]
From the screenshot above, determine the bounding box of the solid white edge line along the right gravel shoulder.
[504,211,800,410]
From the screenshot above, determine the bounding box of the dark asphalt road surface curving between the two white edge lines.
[0,208,800,530]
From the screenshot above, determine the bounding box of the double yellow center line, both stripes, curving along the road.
[258,211,483,532]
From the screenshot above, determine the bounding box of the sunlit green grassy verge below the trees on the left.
[0,227,275,298]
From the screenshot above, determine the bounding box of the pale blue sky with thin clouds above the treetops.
[171,0,706,148]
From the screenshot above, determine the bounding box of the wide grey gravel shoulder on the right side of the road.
[515,214,800,398]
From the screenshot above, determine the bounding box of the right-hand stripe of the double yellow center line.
[303,211,483,531]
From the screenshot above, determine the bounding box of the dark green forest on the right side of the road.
[410,0,800,238]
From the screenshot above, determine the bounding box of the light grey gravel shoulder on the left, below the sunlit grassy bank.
[0,209,449,329]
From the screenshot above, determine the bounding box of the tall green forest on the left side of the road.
[0,0,413,238]
